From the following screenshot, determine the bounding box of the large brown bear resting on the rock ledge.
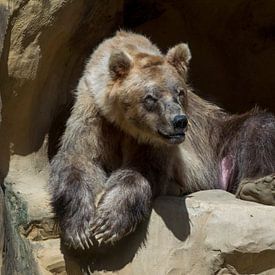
[50,31,275,252]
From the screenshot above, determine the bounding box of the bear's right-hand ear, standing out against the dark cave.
[166,43,191,72]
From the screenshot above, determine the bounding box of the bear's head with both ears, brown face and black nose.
[104,43,191,147]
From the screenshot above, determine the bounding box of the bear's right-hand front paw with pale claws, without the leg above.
[91,200,138,246]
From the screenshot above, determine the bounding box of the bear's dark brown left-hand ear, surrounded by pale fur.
[109,50,132,80]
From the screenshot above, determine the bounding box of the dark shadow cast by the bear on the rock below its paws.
[61,196,190,275]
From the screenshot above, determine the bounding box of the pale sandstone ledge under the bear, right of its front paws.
[63,190,275,275]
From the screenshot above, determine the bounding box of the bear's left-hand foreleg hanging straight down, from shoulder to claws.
[49,93,107,250]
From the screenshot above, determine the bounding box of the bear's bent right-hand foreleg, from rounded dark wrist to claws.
[92,169,152,244]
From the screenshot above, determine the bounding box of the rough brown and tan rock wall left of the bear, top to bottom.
[0,0,123,275]
